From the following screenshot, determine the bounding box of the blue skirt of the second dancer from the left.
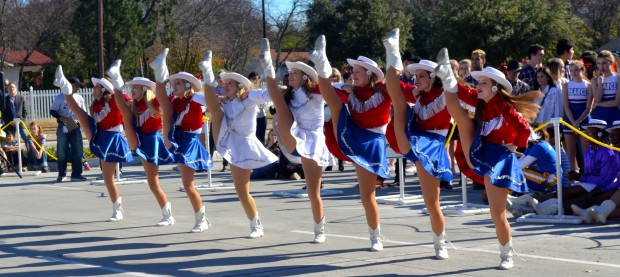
[135,129,174,165]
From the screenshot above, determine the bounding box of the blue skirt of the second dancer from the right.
[404,104,453,181]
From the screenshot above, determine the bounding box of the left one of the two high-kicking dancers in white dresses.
[199,51,278,238]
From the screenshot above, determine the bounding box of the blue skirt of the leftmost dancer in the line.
[88,117,133,163]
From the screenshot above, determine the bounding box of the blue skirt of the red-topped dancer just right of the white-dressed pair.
[337,105,390,179]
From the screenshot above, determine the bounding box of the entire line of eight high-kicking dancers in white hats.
[49,29,541,269]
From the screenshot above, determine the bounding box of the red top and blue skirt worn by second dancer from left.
[134,98,174,165]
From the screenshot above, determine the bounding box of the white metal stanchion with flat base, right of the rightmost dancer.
[517,118,582,224]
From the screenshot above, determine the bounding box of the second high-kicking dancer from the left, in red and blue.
[107,60,175,226]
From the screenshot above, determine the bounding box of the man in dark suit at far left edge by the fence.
[2,83,29,144]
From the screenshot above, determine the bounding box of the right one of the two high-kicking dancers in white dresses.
[259,38,333,243]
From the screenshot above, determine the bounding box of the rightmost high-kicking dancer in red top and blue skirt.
[435,48,541,269]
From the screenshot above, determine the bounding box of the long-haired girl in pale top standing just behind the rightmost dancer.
[534,67,563,124]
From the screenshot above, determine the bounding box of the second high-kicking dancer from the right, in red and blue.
[383,29,452,260]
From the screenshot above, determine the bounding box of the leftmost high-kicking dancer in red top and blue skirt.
[54,65,133,221]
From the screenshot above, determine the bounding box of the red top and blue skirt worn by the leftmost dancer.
[88,95,133,163]
